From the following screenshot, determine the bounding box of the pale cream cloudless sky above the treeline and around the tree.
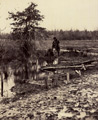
[0,0,98,33]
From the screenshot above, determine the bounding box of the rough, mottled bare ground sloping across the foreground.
[0,72,98,120]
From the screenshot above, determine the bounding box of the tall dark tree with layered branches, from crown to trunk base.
[9,3,44,79]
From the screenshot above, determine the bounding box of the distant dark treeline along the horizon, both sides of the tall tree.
[0,30,98,40]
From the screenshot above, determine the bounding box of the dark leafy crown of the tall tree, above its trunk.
[9,3,44,39]
